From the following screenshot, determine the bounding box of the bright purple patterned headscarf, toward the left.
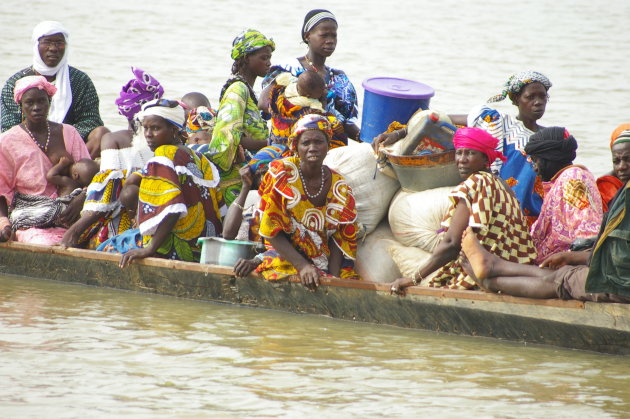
[114,67,164,119]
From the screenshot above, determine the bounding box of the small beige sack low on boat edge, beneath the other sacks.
[354,219,401,282]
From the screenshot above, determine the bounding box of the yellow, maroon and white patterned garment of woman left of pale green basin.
[138,145,223,261]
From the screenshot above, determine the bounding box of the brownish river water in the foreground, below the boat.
[0,277,630,418]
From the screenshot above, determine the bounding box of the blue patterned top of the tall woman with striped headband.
[262,59,359,125]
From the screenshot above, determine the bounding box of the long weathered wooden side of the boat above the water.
[0,242,630,355]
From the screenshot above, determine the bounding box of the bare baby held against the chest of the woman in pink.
[46,155,99,196]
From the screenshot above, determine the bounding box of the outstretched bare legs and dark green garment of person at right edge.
[462,187,630,303]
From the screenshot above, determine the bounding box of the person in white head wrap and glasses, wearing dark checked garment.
[0,21,108,157]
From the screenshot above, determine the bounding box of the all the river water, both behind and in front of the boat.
[0,0,630,418]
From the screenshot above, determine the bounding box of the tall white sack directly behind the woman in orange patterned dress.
[324,141,400,234]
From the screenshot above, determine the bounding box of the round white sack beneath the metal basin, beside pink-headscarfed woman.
[389,186,453,252]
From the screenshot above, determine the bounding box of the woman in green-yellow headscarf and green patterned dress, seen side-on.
[206,29,276,205]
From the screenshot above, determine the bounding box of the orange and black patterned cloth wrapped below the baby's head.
[269,85,348,149]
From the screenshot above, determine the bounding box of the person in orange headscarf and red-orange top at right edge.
[597,124,630,212]
